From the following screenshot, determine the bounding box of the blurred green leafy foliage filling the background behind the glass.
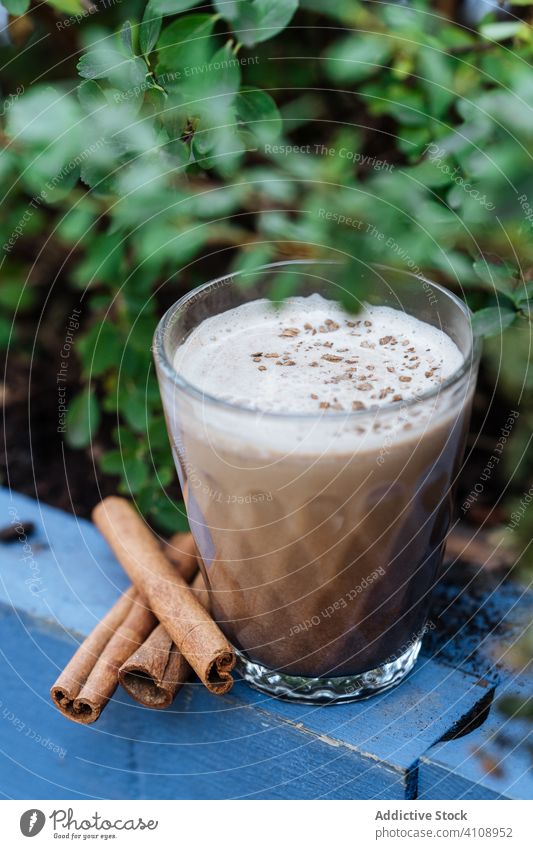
[0,0,533,596]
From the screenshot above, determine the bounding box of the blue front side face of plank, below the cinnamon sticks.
[0,608,407,799]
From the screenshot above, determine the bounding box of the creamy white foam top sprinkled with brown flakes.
[174,294,463,413]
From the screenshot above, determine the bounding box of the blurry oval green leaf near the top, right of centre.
[325,33,392,83]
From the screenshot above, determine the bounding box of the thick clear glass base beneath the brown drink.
[236,638,422,704]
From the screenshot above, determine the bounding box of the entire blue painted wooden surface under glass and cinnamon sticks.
[0,490,533,799]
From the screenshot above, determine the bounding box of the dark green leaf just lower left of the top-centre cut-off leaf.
[157,15,215,76]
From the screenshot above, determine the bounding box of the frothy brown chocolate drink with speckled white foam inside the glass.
[169,294,472,678]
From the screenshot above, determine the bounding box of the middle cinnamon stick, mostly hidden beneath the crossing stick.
[119,573,208,708]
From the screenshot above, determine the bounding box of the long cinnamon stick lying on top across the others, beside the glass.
[93,496,235,694]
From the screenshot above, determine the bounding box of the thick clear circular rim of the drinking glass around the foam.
[153,259,481,421]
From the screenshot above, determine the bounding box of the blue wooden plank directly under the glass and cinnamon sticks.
[0,490,496,799]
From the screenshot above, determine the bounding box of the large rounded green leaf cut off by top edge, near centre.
[215,0,298,47]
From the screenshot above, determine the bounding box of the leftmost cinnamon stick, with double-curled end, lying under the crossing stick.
[50,587,157,725]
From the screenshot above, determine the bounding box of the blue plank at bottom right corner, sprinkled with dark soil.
[418,570,533,799]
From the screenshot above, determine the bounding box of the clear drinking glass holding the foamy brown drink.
[154,260,479,702]
